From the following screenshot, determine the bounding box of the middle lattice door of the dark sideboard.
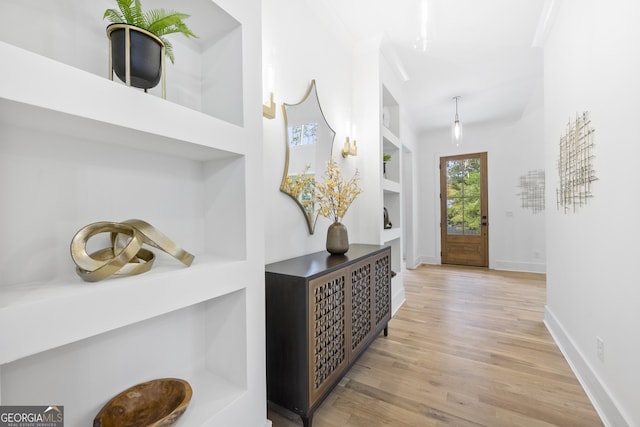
[347,260,374,360]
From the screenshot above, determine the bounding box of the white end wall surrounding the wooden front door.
[416,84,549,272]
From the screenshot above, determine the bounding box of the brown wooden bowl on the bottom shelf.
[93,378,193,427]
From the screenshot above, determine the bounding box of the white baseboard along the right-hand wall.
[544,306,631,427]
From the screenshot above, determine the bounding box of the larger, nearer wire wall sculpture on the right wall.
[556,111,598,213]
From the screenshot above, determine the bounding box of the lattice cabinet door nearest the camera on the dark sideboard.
[309,268,349,406]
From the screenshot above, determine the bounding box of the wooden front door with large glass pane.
[440,153,489,267]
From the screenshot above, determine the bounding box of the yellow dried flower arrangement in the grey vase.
[316,160,362,222]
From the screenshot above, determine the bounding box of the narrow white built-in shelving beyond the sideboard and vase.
[353,36,405,313]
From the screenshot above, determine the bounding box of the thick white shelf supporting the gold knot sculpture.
[0,256,247,365]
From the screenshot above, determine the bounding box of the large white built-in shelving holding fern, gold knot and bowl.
[0,0,266,426]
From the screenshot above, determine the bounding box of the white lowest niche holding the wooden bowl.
[2,290,247,426]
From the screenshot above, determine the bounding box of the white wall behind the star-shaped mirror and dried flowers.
[259,0,358,263]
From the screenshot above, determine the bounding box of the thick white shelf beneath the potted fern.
[0,42,245,160]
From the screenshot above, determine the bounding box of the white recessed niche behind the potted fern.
[0,0,244,125]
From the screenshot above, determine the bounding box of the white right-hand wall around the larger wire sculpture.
[545,0,640,427]
